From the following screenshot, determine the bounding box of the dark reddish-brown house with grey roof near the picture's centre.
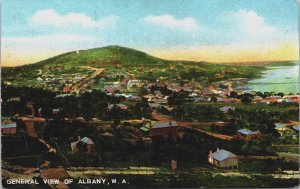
[150,121,178,138]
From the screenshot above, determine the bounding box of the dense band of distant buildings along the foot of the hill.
[29,66,300,107]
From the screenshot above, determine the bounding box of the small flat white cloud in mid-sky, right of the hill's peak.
[141,15,200,32]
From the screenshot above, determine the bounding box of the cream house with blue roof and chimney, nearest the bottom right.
[208,148,238,168]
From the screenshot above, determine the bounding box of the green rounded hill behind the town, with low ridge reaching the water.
[2,46,264,85]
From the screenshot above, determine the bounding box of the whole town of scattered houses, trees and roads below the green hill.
[1,47,300,188]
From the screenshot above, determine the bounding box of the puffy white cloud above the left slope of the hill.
[29,9,117,28]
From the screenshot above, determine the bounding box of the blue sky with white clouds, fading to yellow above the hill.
[1,0,299,66]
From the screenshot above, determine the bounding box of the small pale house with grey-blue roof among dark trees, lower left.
[71,136,95,153]
